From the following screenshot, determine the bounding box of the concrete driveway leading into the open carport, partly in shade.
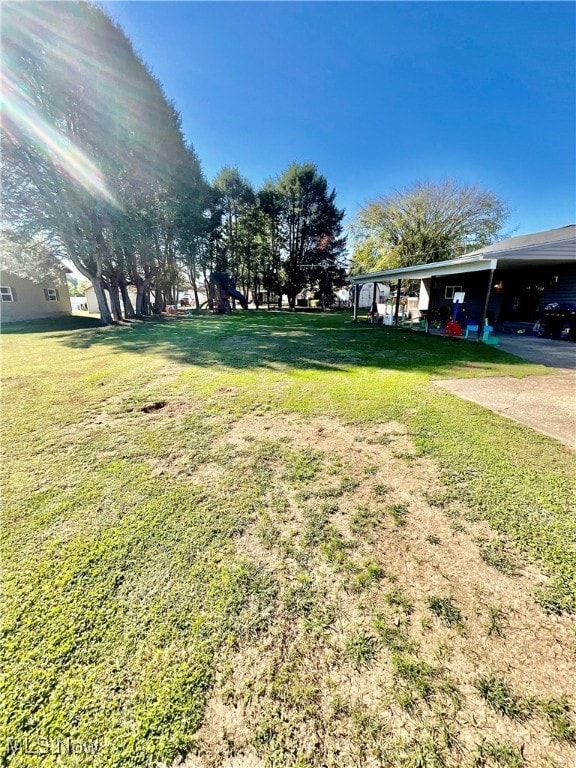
[434,336,576,450]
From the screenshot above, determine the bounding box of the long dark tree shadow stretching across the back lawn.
[45,311,531,376]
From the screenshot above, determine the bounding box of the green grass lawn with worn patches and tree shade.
[1,312,576,768]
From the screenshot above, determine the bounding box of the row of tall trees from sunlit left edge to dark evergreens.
[2,2,345,323]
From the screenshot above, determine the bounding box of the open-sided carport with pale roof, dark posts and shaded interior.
[351,224,576,338]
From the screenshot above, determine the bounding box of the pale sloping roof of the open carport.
[350,224,576,284]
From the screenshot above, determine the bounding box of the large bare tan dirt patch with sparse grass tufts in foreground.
[183,416,576,768]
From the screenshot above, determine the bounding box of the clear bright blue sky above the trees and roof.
[103,2,576,234]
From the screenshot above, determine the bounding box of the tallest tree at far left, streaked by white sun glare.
[2,2,191,322]
